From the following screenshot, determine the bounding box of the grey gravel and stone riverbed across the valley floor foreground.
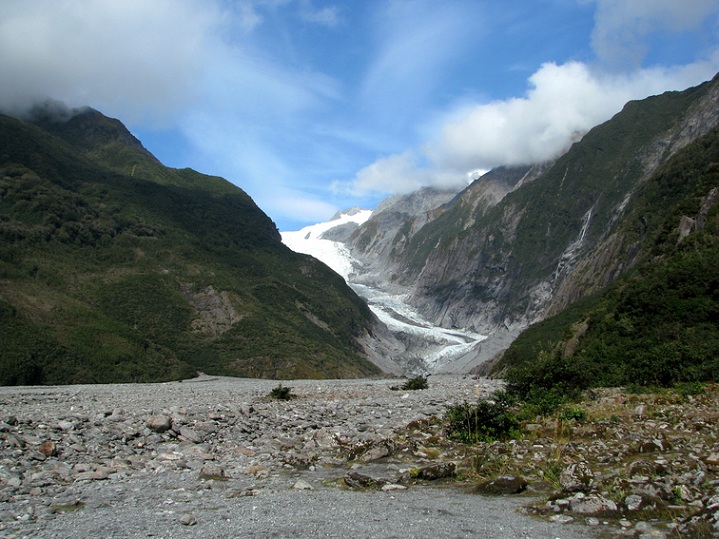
[0,376,620,539]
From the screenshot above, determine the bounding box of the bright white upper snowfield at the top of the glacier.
[280,208,372,282]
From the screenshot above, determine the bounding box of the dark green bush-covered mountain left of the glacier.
[0,108,380,384]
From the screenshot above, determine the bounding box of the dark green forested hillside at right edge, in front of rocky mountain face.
[495,128,719,392]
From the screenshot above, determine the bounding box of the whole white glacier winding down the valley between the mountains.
[281,209,486,373]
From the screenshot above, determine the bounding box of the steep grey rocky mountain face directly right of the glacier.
[340,78,719,368]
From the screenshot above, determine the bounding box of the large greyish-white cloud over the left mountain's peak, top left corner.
[0,0,224,120]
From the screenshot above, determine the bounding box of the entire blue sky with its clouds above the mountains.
[0,0,719,230]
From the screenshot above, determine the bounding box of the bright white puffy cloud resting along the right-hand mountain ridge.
[344,58,719,193]
